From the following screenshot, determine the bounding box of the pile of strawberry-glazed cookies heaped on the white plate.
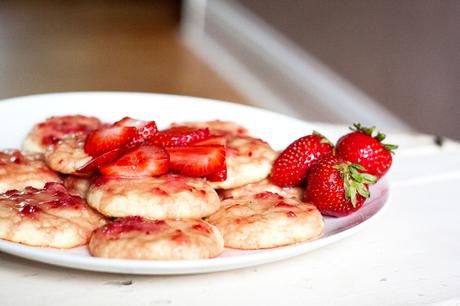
[0,115,324,260]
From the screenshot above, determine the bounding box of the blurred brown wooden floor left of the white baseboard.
[0,0,250,104]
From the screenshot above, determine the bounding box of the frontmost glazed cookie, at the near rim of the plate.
[89,216,224,260]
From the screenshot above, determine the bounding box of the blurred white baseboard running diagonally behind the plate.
[181,0,411,131]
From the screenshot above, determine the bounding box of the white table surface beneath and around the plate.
[0,134,460,306]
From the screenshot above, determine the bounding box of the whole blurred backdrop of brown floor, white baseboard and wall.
[0,0,460,140]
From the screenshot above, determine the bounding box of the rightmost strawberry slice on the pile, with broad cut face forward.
[166,146,225,177]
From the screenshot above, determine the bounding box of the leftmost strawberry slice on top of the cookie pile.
[85,126,136,157]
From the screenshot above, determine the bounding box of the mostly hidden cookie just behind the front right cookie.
[220,179,303,201]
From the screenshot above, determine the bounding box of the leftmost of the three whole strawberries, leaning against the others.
[271,132,334,187]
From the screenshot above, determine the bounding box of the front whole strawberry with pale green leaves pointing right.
[304,156,377,217]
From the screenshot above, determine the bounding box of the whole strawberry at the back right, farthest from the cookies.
[336,123,397,178]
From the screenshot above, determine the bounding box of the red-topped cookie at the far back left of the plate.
[22,115,102,153]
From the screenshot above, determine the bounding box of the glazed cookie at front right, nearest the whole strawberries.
[208,192,324,249]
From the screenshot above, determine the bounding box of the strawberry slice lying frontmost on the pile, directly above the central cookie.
[101,145,169,177]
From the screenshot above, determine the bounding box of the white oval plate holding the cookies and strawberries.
[0,92,389,274]
